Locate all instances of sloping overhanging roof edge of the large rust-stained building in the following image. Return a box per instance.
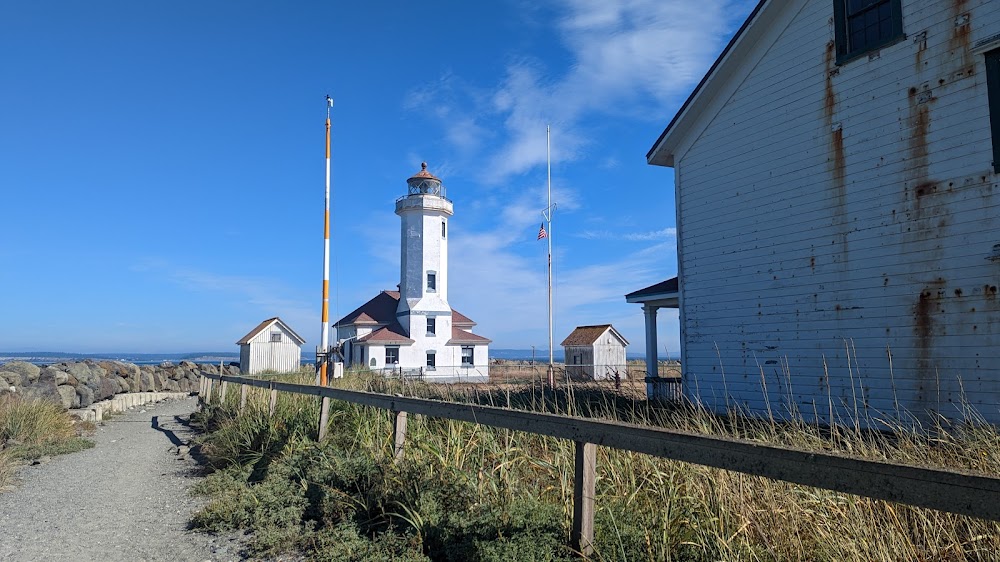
[646,0,772,167]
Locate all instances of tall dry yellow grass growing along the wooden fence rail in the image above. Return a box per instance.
[197,366,1000,562]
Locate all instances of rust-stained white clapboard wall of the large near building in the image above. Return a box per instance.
[675,0,1000,422]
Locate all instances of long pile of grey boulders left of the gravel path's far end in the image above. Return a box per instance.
[0,359,240,409]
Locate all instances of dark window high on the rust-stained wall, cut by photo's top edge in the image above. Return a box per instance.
[833,0,903,64]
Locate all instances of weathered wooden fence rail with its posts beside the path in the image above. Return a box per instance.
[201,373,1000,555]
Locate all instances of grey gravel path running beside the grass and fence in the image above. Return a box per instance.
[0,398,248,562]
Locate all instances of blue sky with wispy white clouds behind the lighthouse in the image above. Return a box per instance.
[0,0,755,356]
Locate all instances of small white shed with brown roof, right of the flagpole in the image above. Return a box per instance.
[560,324,628,380]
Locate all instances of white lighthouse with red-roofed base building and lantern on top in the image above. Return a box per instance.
[335,163,490,382]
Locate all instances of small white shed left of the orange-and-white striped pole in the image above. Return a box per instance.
[236,316,306,375]
